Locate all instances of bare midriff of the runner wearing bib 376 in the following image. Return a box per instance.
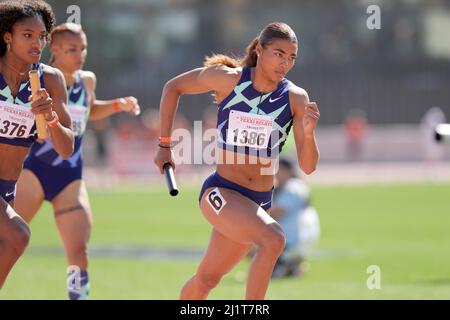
[0,143,29,181]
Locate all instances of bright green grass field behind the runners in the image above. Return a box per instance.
[0,184,450,299]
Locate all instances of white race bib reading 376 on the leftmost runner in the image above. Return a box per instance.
[0,101,35,138]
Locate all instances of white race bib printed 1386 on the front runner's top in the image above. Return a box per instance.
[227,110,273,149]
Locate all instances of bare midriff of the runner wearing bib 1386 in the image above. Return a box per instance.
[217,149,274,192]
